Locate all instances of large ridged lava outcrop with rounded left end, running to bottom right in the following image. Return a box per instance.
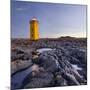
[30,48,84,85]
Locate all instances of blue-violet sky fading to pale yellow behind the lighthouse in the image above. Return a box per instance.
[11,0,87,38]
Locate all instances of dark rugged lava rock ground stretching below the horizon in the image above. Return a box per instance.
[11,37,87,90]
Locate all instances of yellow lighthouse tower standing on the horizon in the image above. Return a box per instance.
[30,18,39,40]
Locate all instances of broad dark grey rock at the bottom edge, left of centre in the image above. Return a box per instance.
[24,72,53,88]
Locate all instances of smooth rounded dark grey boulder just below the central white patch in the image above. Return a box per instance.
[39,52,58,73]
